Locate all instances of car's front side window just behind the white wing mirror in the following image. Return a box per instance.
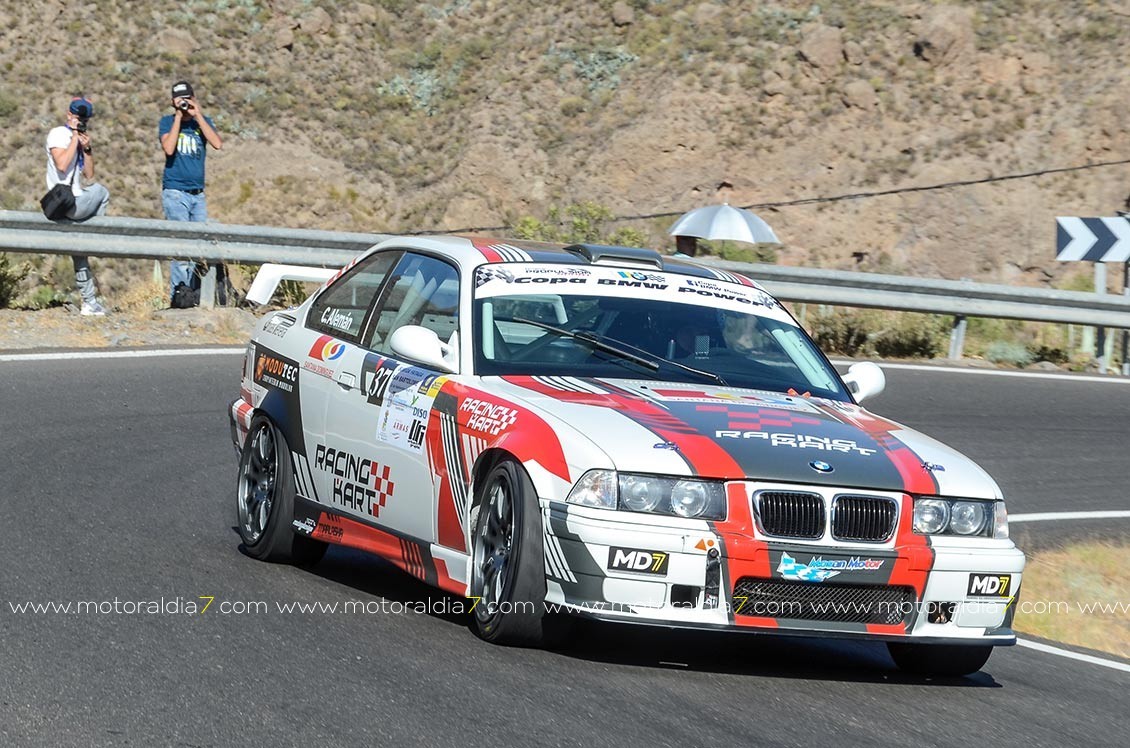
[365,253,459,355]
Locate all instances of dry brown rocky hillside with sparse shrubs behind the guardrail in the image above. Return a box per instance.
[0,0,1130,284]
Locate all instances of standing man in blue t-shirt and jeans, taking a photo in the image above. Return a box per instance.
[157,80,224,298]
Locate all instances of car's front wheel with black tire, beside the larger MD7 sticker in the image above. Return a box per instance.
[470,459,570,646]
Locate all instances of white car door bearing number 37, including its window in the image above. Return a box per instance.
[325,252,459,542]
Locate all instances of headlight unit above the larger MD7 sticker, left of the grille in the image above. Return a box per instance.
[565,470,725,520]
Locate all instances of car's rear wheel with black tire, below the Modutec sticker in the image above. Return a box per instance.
[235,414,327,566]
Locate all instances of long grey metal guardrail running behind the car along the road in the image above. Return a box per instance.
[0,210,1130,358]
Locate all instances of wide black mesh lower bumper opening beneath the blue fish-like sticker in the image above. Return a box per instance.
[733,576,916,625]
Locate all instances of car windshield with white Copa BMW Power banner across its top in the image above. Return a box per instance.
[475,263,850,401]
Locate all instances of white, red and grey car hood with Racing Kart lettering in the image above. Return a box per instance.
[499,376,1000,498]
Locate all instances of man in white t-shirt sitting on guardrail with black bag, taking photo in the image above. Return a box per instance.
[46,95,110,316]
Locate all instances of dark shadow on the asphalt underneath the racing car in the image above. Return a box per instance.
[259,546,1001,688]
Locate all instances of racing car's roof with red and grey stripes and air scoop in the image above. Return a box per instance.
[374,235,764,290]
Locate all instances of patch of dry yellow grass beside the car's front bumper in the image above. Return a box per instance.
[1015,542,1130,658]
